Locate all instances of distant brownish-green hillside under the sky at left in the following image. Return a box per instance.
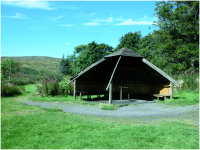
[1,56,61,70]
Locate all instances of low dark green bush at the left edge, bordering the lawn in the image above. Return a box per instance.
[1,82,25,97]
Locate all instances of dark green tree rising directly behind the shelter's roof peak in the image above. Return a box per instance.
[114,31,142,51]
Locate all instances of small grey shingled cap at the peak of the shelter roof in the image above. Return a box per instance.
[105,48,143,58]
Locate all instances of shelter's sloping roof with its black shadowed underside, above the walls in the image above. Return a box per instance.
[68,48,179,86]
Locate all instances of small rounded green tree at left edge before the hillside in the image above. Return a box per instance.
[1,59,20,80]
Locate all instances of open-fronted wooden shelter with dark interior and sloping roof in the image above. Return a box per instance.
[68,48,179,104]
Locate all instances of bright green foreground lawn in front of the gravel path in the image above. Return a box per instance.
[1,85,199,149]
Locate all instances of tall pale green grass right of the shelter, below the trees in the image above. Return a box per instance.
[172,73,199,93]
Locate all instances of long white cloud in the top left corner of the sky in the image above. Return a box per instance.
[1,0,55,10]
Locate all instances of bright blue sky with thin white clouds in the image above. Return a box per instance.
[1,0,157,57]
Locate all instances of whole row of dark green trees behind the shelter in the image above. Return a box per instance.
[59,1,199,75]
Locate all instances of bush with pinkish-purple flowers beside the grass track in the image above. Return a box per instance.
[36,78,59,96]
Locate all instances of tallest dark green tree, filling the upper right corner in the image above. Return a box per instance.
[155,1,199,71]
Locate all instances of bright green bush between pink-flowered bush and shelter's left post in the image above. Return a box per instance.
[59,78,74,96]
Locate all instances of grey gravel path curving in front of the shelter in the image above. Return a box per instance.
[21,100,199,125]
